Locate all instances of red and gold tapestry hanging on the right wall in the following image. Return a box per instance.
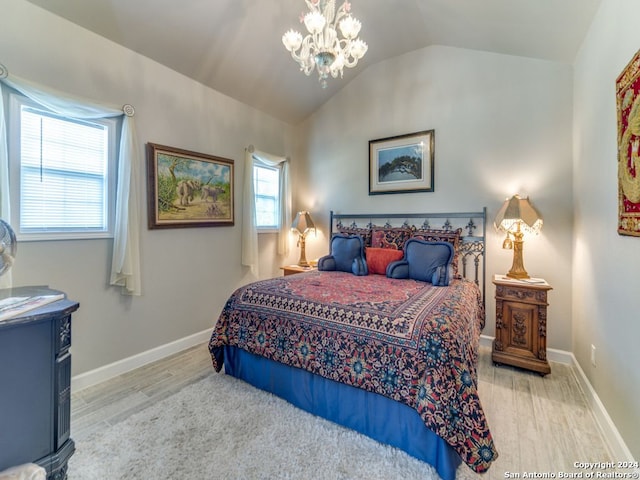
[616,50,640,236]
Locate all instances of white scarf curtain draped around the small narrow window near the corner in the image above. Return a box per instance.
[242,145,291,278]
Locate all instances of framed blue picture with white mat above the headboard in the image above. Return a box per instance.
[369,130,435,195]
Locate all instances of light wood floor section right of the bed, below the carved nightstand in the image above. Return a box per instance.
[458,347,612,479]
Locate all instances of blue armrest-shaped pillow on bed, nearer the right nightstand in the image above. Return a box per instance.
[387,238,453,286]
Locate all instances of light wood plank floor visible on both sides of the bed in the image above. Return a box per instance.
[71,344,613,479]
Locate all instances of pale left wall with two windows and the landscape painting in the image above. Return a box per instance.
[0,0,291,375]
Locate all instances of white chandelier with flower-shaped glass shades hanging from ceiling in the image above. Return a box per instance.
[282,0,368,88]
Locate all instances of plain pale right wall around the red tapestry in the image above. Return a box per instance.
[573,0,640,459]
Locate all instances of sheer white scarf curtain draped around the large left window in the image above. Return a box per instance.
[0,68,142,295]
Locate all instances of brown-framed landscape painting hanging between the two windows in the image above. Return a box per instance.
[147,143,234,229]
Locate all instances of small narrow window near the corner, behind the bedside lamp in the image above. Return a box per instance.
[253,161,280,232]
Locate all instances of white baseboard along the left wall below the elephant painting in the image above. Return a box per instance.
[71,329,211,392]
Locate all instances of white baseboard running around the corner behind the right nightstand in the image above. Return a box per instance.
[480,335,635,462]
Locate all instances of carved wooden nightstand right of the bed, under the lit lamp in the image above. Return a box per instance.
[491,275,551,375]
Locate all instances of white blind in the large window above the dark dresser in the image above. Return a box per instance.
[20,106,109,233]
